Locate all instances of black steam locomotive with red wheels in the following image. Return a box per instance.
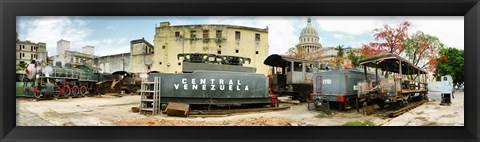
[22,60,104,98]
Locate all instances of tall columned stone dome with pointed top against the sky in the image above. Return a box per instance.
[296,18,322,54]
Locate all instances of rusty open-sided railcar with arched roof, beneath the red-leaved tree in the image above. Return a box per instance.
[357,53,428,107]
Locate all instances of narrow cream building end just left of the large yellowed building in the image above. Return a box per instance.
[130,38,155,73]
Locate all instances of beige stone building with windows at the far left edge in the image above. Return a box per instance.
[15,34,48,67]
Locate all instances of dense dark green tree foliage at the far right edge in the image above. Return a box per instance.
[435,48,465,85]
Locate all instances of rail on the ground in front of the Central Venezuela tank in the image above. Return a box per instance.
[188,106,290,115]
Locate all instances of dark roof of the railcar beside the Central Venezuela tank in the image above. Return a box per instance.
[263,54,316,67]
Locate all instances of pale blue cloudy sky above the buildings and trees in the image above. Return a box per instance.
[16,16,464,56]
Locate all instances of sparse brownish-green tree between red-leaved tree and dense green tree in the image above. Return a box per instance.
[403,31,445,71]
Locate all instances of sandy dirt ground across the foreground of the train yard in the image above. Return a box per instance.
[17,92,464,126]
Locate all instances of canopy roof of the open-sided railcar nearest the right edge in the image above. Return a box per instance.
[360,53,427,75]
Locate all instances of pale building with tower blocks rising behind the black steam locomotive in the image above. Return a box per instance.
[53,39,95,66]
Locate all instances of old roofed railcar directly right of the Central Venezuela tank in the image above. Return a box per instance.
[263,54,326,101]
